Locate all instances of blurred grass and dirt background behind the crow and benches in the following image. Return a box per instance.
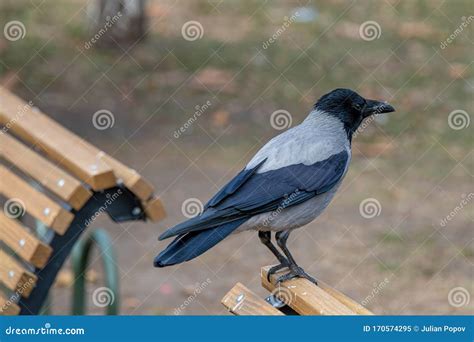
[0,0,474,315]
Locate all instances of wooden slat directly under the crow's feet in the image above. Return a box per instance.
[261,266,355,315]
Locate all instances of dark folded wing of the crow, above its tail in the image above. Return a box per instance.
[160,151,349,240]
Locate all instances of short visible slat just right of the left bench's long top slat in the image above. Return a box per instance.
[100,153,153,201]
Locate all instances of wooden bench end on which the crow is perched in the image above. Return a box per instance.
[221,266,373,316]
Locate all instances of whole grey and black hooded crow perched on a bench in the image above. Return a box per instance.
[154,89,395,283]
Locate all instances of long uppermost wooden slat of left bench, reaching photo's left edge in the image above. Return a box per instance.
[0,87,116,190]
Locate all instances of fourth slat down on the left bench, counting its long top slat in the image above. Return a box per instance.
[0,212,52,268]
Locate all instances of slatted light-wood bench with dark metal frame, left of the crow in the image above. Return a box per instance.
[0,87,165,315]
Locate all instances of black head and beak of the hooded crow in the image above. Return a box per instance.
[314,88,395,136]
